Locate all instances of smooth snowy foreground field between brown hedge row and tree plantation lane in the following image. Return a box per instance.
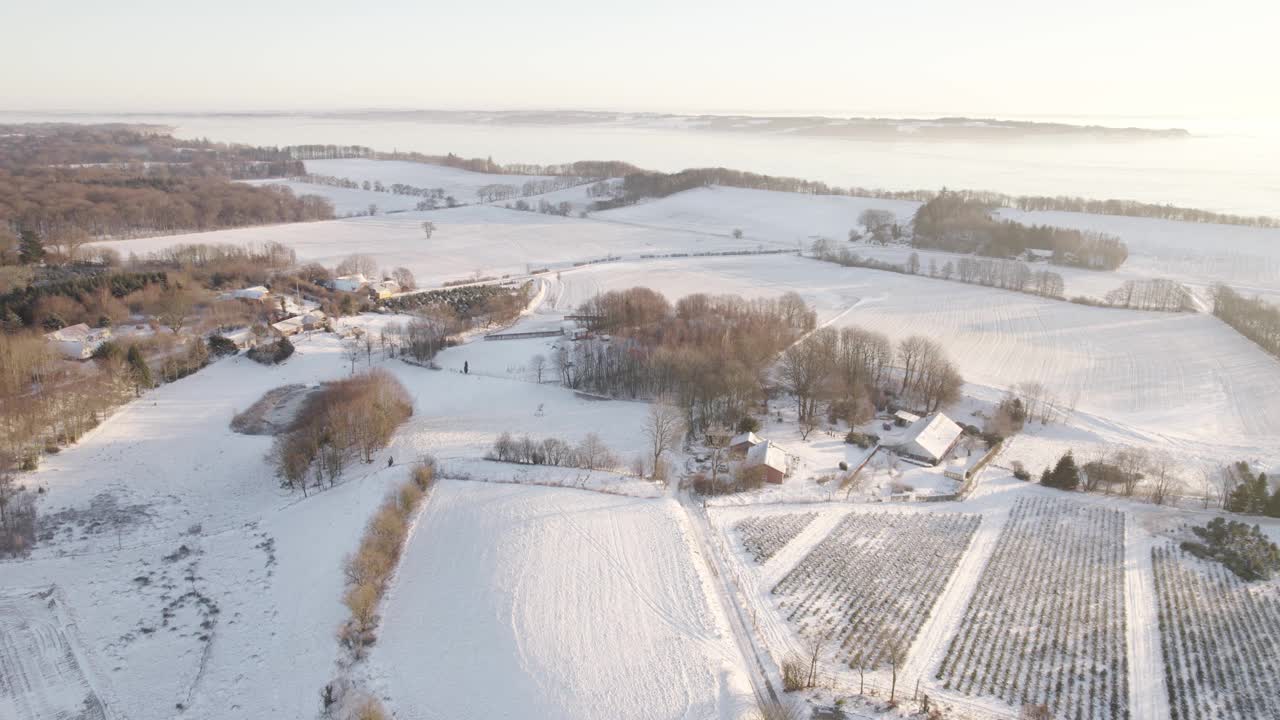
[370,480,751,719]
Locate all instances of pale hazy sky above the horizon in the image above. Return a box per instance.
[0,0,1280,119]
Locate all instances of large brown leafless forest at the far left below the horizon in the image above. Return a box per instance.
[0,124,333,250]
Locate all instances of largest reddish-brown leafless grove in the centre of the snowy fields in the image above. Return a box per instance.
[553,288,815,433]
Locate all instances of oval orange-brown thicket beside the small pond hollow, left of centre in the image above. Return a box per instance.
[268,369,413,495]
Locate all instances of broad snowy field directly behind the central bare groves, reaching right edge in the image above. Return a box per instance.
[550,256,1280,471]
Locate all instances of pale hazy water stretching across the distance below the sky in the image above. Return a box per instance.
[0,113,1280,215]
